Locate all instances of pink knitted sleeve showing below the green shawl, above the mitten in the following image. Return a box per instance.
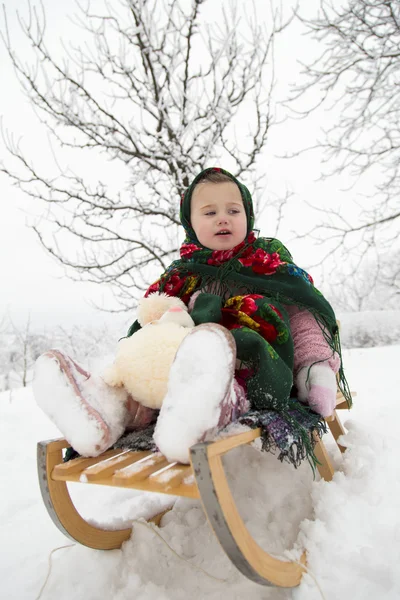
[285,306,340,374]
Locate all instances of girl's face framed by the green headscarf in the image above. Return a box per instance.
[190,181,247,250]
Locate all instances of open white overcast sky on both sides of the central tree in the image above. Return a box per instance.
[0,0,378,325]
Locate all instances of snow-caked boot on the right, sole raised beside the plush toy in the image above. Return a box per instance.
[154,323,244,463]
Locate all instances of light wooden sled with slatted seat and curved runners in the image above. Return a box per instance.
[38,386,347,587]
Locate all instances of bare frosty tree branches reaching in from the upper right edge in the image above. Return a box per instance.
[292,0,400,274]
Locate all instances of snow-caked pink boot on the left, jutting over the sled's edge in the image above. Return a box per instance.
[32,350,129,456]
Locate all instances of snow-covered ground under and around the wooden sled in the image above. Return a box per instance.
[0,346,400,600]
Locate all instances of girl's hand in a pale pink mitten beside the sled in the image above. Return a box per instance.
[296,363,337,417]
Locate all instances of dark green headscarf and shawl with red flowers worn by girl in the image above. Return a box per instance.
[128,168,351,468]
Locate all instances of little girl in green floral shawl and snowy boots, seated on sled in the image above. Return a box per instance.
[34,168,351,465]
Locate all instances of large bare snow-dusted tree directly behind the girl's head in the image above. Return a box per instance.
[1,0,290,310]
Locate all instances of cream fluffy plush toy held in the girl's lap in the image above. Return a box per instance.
[103,293,194,408]
